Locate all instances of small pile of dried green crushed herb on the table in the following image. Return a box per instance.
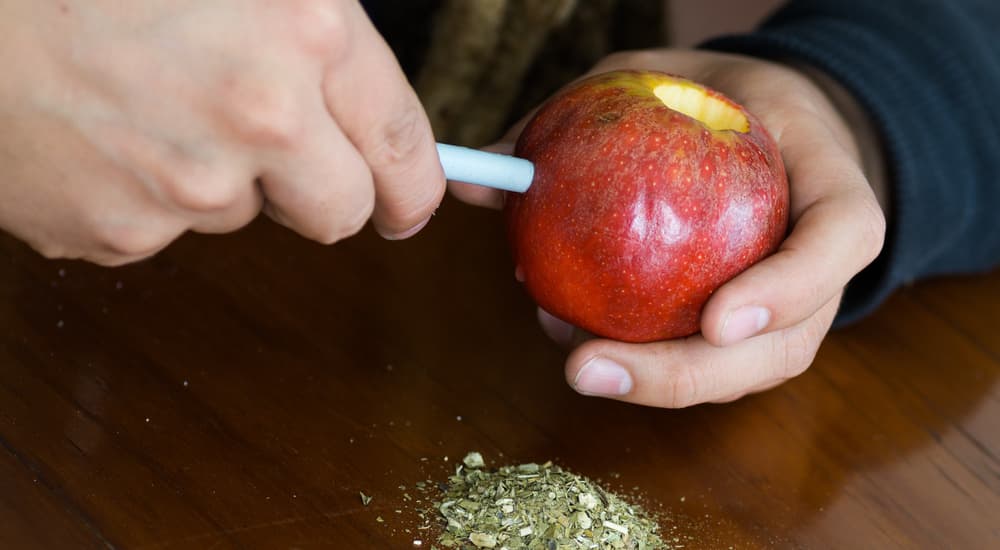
[437,453,667,550]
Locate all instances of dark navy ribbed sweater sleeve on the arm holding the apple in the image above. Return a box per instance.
[702,0,1000,325]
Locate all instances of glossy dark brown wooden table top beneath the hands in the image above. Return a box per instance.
[0,200,1000,549]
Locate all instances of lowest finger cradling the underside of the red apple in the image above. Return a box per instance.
[566,299,838,408]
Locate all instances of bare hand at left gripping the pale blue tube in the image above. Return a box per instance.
[0,0,445,265]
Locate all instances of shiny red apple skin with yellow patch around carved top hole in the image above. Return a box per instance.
[504,71,789,342]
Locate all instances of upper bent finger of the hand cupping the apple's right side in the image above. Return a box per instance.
[701,119,885,346]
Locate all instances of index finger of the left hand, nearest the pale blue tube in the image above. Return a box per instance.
[323,2,445,238]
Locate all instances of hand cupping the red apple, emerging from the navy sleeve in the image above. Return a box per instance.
[452,50,885,407]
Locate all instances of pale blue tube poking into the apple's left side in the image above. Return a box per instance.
[437,143,535,193]
